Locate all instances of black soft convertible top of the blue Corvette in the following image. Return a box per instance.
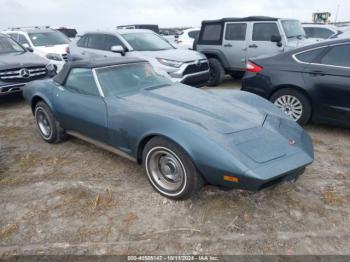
[53,57,147,85]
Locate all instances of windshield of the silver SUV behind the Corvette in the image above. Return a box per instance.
[123,33,174,51]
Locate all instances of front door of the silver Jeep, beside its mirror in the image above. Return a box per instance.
[247,22,283,59]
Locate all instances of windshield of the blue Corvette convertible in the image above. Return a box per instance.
[96,63,171,97]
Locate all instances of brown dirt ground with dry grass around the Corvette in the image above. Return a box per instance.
[0,81,350,255]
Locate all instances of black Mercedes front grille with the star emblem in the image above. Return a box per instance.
[0,66,47,82]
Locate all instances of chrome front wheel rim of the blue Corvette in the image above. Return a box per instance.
[146,147,186,194]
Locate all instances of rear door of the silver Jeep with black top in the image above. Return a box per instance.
[222,22,248,69]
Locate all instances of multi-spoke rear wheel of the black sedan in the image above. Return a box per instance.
[270,88,311,125]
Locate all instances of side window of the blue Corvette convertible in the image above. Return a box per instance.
[64,68,100,96]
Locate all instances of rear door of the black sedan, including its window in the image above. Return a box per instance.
[304,43,350,123]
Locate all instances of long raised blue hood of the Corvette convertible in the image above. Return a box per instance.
[126,84,266,134]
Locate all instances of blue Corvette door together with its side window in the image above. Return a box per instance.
[54,68,109,143]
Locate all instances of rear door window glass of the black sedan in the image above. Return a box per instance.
[321,44,350,67]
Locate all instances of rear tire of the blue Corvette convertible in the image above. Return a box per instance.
[34,101,67,144]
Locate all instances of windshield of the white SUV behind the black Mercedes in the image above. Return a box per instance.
[28,32,69,46]
